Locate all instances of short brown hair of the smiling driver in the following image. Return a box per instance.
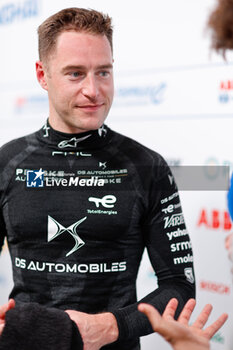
[38,7,113,60]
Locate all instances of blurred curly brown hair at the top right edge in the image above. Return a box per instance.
[208,0,233,57]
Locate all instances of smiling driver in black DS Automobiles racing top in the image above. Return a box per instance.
[0,9,195,350]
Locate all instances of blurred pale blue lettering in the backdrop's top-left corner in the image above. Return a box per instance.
[0,0,39,25]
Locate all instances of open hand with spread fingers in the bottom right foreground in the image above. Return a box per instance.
[138,299,228,350]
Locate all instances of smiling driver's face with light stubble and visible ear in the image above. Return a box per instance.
[36,31,114,133]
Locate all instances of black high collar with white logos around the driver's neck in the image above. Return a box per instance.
[37,120,112,151]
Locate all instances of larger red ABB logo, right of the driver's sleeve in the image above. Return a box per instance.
[197,209,232,231]
